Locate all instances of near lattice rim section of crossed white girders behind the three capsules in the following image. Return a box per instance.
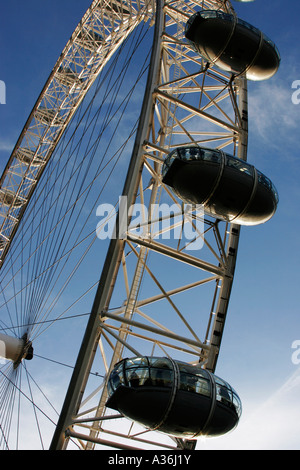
[47,1,247,448]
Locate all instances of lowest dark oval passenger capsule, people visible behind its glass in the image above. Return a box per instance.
[106,357,241,439]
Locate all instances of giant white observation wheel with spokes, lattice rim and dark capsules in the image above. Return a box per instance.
[0,0,280,449]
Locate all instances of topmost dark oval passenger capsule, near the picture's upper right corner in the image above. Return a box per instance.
[185,10,280,80]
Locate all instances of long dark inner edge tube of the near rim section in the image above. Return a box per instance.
[51,0,163,449]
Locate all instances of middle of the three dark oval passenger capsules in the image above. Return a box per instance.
[162,147,278,225]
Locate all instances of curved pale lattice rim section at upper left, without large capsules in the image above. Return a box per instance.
[0,0,153,267]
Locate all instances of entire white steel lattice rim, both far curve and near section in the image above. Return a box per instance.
[0,0,247,449]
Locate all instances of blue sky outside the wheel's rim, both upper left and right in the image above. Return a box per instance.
[0,0,300,449]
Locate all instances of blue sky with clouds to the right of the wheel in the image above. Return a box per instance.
[206,0,300,449]
